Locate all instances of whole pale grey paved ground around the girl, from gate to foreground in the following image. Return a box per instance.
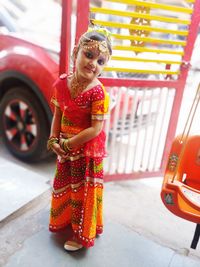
[0,151,200,267]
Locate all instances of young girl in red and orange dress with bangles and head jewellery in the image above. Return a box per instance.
[47,29,112,251]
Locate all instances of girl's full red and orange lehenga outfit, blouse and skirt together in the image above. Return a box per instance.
[49,76,109,247]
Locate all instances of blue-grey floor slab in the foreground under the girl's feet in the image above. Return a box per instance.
[2,210,200,267]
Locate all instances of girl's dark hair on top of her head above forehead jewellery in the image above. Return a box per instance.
[79,30,112,55]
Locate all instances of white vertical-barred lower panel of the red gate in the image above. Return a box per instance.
[105,87,175,174]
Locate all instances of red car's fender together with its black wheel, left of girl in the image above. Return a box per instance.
[0,34,58,161]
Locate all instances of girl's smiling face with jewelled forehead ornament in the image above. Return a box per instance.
[75,42,109,81]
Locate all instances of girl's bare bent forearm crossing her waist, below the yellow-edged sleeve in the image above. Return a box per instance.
[69,120,103,148]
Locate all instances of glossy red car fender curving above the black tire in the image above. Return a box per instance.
[0,35,58,111]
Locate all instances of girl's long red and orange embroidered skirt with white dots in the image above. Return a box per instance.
[49,151,103,247]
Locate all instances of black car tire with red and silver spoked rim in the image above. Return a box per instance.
[0,87,50,162]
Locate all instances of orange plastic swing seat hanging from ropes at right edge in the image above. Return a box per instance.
[161,85,200,249]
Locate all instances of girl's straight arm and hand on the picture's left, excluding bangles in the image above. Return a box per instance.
[50,106,66,157]
